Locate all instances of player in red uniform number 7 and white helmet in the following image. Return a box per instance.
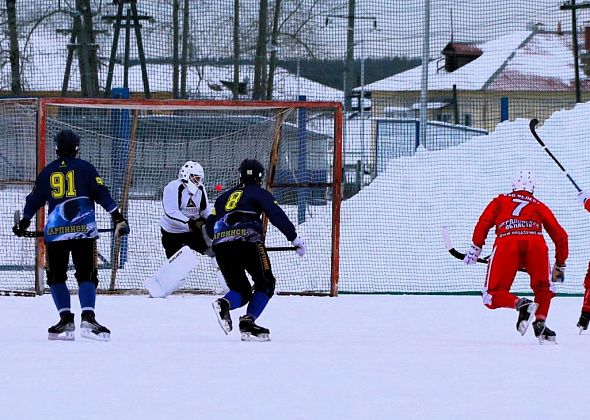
[463,170,568,343]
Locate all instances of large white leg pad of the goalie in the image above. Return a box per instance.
[144,245,197,298]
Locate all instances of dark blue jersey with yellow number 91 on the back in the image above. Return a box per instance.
[23,157,117,242]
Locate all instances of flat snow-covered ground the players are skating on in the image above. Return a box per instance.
[0,295,590,420]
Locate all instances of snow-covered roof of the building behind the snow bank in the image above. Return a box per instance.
[364,31,585,92]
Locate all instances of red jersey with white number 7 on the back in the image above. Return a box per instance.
[473,191,569,264]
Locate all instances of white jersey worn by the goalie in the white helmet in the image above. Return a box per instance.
[160,179,211,233]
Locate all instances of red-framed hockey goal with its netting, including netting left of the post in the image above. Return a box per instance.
[0,98,342,296]
